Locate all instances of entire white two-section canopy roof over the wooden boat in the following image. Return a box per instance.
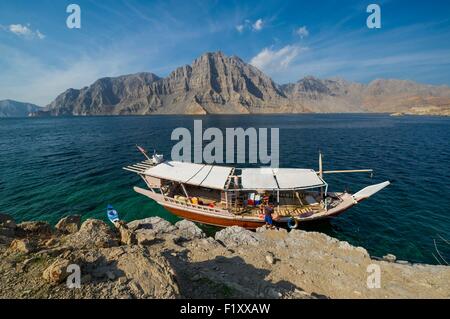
[144,161,326,190]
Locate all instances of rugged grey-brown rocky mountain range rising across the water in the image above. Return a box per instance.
[32,52,450,116]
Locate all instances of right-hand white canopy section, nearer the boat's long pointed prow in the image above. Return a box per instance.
[241,168,326,190]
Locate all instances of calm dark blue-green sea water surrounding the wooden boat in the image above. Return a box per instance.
[0,115,450,264]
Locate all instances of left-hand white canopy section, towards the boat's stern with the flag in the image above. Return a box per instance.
[145,161,232,189]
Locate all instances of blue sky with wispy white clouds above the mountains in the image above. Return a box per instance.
[0,0,450,105]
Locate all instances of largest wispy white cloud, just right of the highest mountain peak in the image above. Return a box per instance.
[250,45,306,72]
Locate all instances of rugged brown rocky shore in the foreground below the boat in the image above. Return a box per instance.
[0,214,450,298]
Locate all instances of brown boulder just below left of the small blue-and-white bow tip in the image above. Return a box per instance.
[65,219,119,249]
